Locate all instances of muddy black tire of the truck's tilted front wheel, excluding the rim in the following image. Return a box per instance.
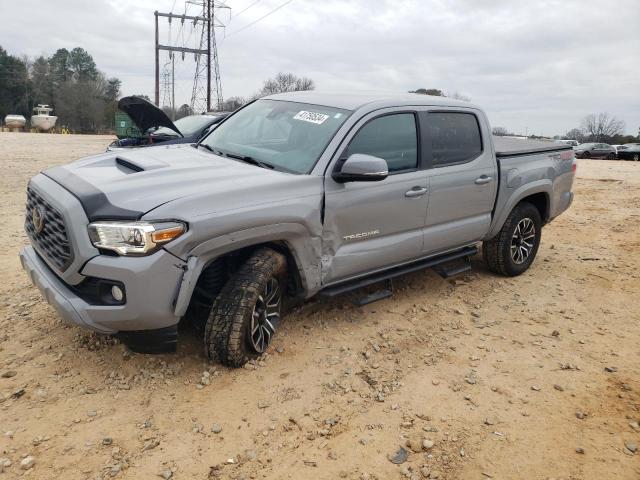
[204,248,287,367]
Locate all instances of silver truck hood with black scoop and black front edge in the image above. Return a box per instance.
[43,145,317,221]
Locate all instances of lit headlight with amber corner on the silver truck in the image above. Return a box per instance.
[89,222,186,255]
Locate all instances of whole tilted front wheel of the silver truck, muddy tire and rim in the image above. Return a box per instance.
[204,248,286,367]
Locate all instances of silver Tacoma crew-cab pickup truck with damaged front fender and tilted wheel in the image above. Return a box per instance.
[20,92,575,366]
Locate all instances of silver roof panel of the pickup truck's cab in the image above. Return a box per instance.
[264,90,478,110]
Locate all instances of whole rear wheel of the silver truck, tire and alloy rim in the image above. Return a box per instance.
[482,202,542,277]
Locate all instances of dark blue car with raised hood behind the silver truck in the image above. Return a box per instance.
[107,96,229,151]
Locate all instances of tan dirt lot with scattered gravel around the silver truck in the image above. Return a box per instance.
[0,133,640,480]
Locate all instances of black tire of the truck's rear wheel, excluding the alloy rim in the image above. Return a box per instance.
[482,202,542,277]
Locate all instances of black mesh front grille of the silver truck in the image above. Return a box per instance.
[24,188,73,272]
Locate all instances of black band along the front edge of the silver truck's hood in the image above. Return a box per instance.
[42,167,144,222]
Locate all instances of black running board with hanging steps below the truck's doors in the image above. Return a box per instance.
[319,246,478,303]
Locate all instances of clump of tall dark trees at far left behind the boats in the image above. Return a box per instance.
[0,47,122,133]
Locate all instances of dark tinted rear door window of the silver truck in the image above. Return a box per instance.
[427,112,482,167]
